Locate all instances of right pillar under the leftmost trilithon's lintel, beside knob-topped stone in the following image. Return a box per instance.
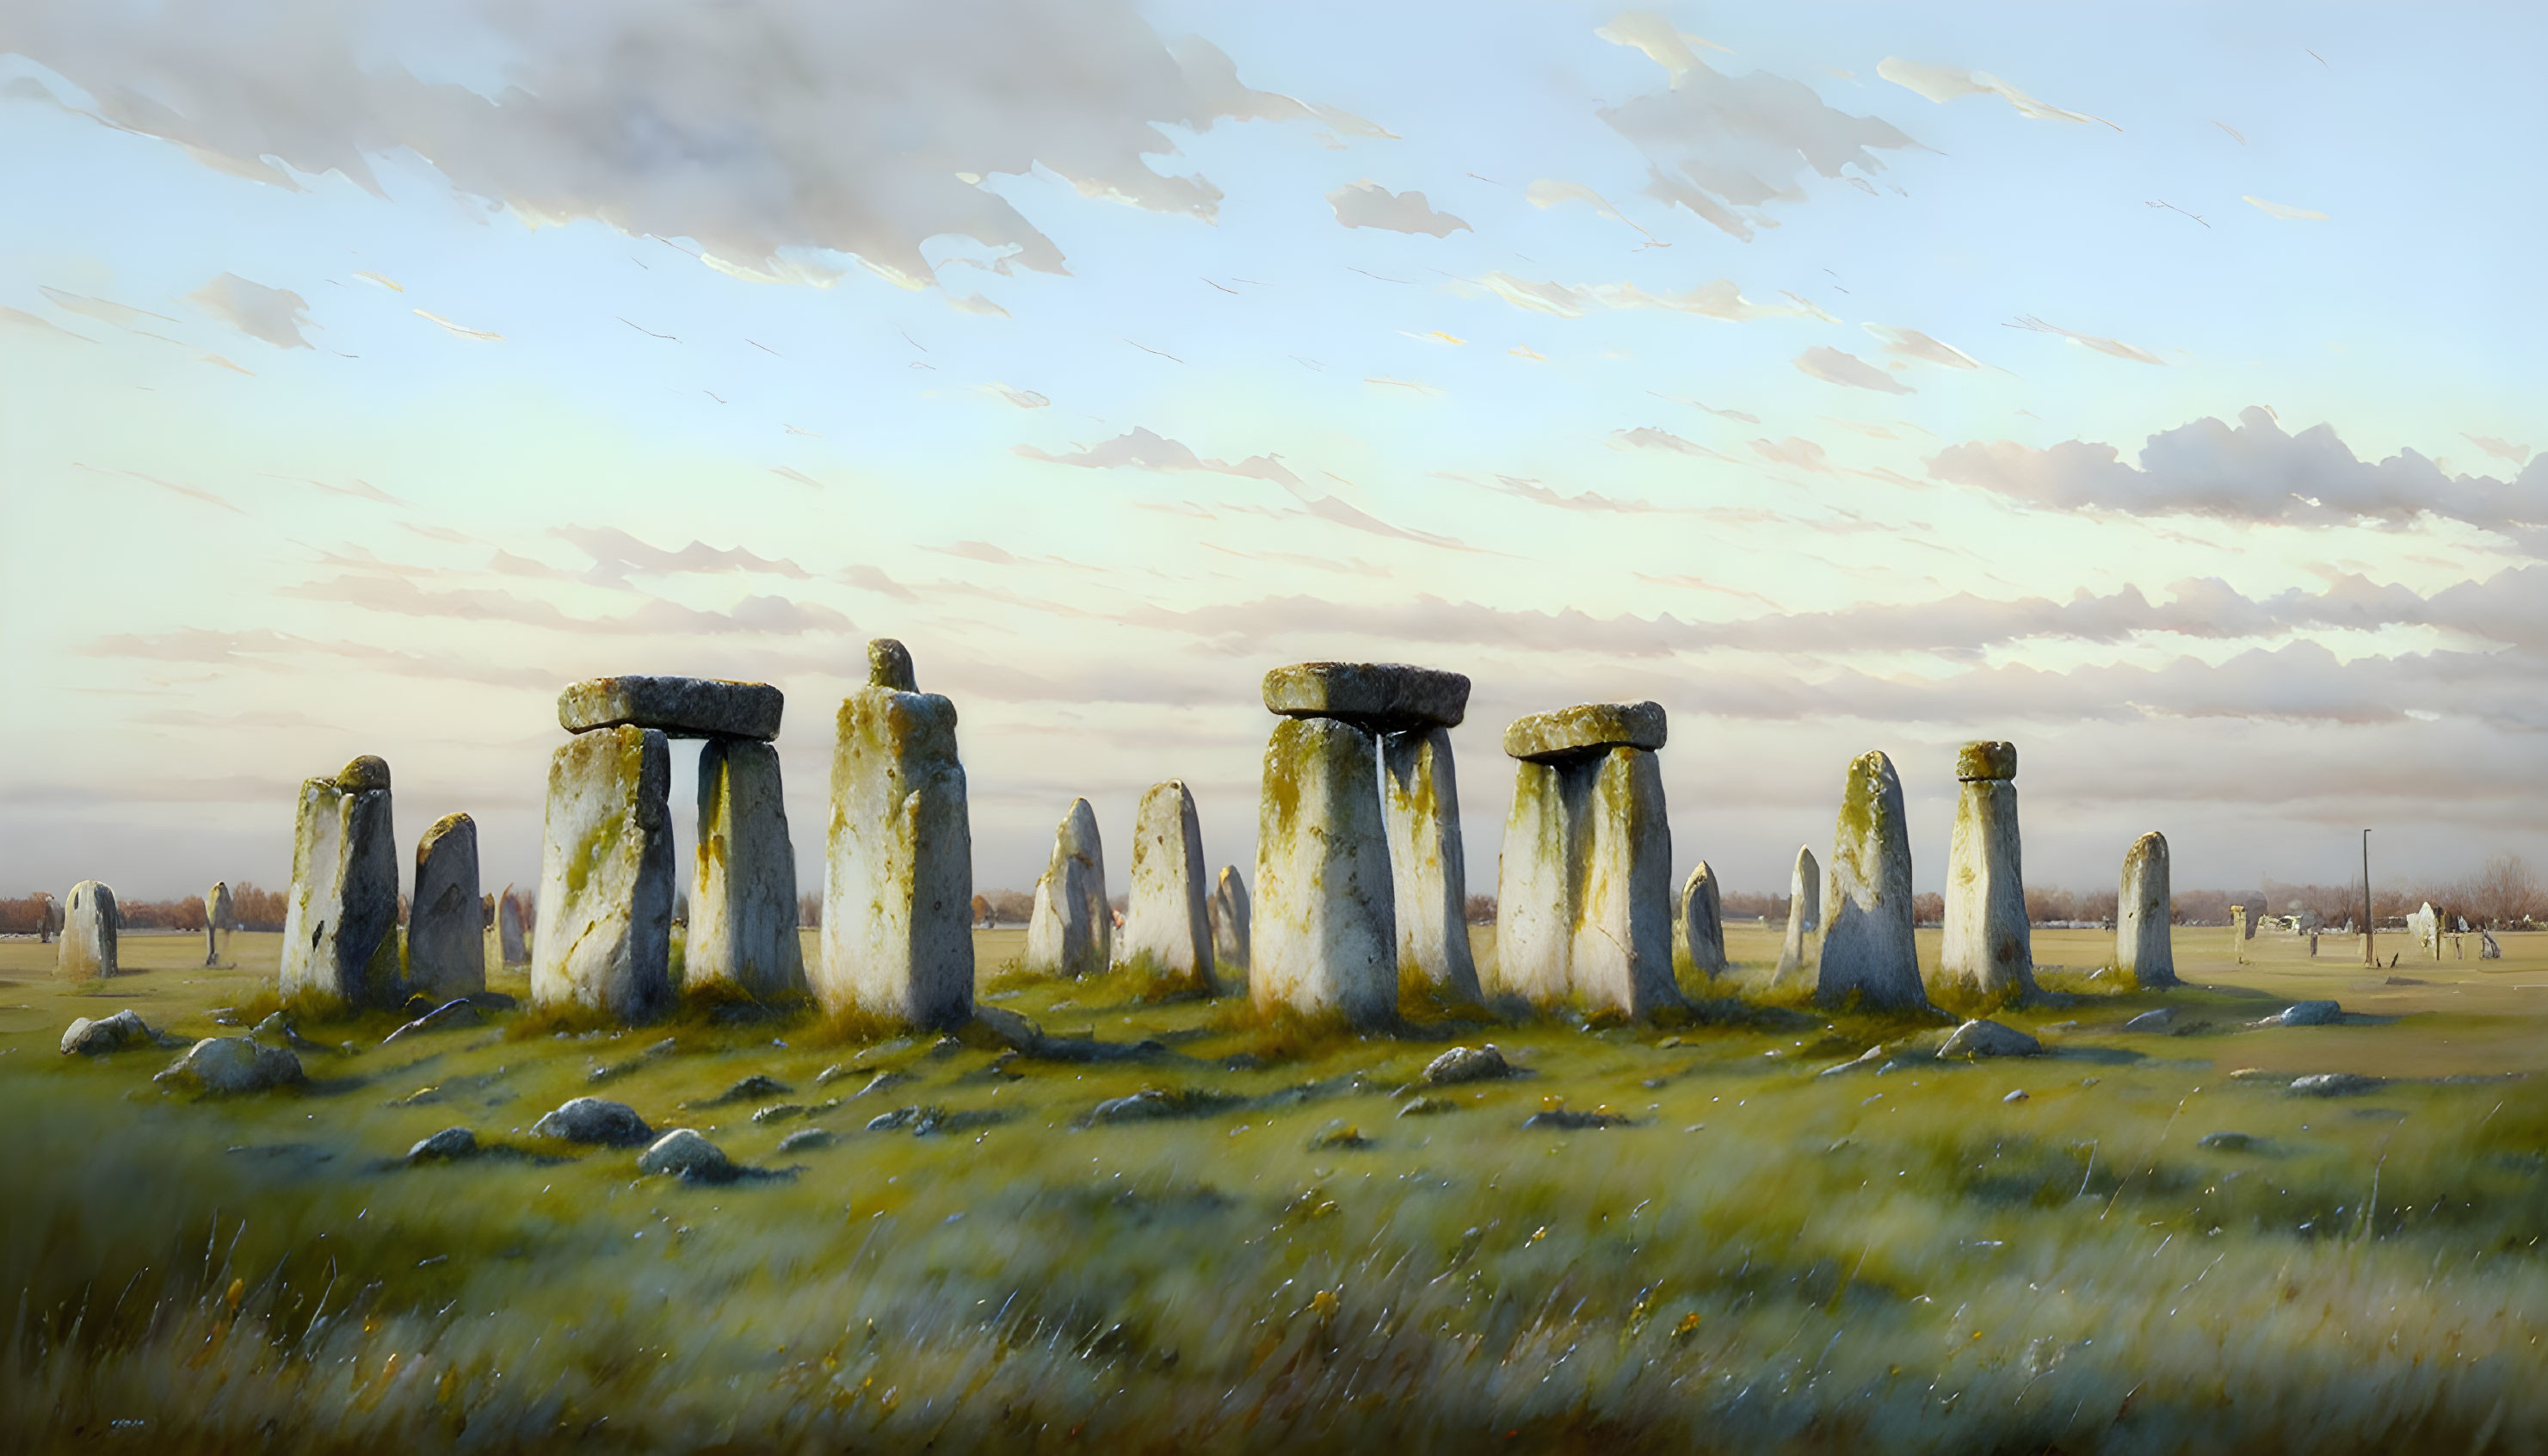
[681,737,808,1003]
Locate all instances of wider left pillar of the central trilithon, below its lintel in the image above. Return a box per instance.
[1249,719,1399,1025]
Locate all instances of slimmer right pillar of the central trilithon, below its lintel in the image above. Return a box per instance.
[1381,724,1483,1003]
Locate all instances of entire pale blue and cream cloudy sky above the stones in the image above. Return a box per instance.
[0,0,2548,898]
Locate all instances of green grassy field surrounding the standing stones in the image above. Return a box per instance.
[0,926,2548,1453]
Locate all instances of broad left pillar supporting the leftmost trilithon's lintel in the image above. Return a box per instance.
[530,727,673,1022]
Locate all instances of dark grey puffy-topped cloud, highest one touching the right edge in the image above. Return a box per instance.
[1928,405,2548,530]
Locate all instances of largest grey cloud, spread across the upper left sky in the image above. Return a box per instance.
[10,0,1389,286]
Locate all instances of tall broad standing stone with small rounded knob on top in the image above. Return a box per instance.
[813,638,973,1025]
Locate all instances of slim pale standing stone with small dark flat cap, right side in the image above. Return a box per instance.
[1931,742,2036,1003]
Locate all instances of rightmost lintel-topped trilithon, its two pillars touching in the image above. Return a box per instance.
[1488,704,1681,1017]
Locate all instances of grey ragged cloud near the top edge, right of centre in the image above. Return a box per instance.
[1598,10,1919,243]
